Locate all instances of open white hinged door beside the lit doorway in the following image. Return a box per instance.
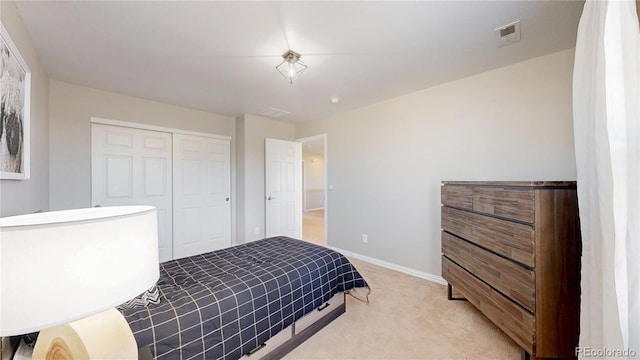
[265,139,302,239]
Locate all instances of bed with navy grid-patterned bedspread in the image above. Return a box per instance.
[121,236,368,359]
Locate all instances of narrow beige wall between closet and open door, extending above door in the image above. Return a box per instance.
[236,114,295,243]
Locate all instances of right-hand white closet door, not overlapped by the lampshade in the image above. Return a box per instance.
[173,134,231,258]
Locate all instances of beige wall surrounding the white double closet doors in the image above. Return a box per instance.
[49,80,235,209]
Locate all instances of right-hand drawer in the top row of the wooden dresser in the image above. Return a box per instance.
[473,187,535,223]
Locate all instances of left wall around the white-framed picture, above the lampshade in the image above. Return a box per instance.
[0,0,49,216]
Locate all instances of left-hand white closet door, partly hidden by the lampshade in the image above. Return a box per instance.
[91,124,173,261]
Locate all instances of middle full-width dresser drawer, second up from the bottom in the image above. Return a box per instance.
[442,232,535,313]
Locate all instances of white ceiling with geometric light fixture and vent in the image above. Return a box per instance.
[17,1,583,122]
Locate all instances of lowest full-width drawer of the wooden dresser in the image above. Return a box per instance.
[442,256,535,354]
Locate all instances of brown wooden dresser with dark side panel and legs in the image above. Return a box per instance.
[441,181,582,359]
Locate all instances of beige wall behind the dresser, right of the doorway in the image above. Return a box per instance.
[296,50,576,275]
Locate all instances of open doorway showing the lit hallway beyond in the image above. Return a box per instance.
[297,134,328,246]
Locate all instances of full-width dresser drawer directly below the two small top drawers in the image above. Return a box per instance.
[442,207,535,267]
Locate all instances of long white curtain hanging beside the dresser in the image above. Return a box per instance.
[573,0,640,358]
